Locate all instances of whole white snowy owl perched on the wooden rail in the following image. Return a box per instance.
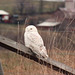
[24,25,48,59]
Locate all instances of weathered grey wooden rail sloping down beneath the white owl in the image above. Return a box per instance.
[0,35,75,75]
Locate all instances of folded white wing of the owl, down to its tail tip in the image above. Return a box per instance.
[27,32,48,58]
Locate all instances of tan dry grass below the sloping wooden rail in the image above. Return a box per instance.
[0,51,64,75]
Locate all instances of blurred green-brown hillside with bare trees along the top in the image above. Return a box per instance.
[0,0,64,14]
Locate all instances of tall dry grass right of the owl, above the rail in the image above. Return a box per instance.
[40,30,75,69]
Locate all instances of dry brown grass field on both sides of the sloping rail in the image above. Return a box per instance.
[0,24,75,75]
